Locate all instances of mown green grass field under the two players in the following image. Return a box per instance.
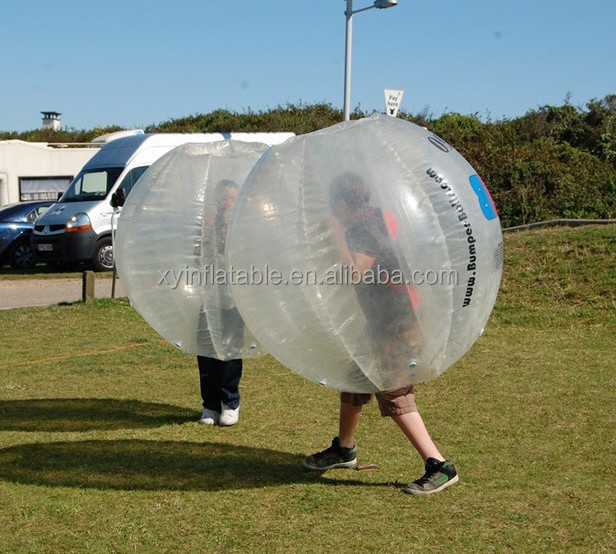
[0,226,616,552]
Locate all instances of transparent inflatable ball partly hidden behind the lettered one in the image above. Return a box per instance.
[115,140,268,360]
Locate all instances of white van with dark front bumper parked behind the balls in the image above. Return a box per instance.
[31,129,294,271]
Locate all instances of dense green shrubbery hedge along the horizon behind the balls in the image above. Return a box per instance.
[0,95,616,227]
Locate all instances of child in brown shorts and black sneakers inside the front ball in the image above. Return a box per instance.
[304,173,459,494]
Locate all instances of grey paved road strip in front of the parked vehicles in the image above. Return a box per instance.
[0,277,126,310]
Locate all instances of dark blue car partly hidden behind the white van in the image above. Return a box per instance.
[0,200,54,269]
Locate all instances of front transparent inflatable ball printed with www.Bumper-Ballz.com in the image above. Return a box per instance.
[227,115,503,392]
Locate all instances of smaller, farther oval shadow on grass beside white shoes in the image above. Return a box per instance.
[0,398,197,432]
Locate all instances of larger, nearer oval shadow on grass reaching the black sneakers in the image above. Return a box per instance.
[0,439,390,491]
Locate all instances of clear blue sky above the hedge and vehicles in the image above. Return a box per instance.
[0,0,616,132]
